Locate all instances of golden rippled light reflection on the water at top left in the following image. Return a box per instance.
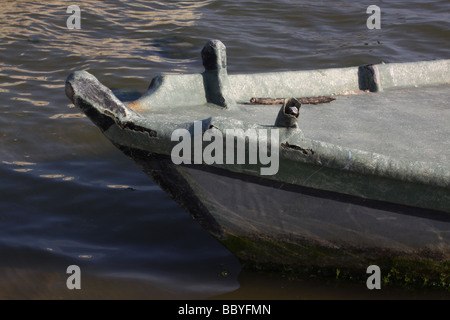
[0,0,211,63]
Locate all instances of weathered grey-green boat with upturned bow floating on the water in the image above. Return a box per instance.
[66,40,450,287]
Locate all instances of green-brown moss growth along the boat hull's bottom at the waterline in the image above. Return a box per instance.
[223,235,450,291]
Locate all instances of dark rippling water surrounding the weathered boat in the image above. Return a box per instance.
[0,0,450,299]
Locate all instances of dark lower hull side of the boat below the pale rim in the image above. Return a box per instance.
[118,146,450,286]
